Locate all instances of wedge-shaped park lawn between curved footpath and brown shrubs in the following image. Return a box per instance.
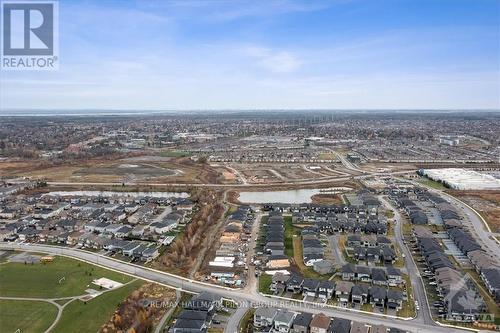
[53,281,144,333]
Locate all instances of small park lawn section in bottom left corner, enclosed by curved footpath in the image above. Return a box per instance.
[0,300,57,333]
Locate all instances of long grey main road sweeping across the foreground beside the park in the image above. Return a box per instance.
[0,242,470,333]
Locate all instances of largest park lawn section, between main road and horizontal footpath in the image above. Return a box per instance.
[0,253,131,298]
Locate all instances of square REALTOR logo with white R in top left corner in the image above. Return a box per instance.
[1,1,58,70]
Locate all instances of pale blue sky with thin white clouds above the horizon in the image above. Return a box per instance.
[0,0,500,112]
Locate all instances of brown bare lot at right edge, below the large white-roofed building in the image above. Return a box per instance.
[447,190,500,232]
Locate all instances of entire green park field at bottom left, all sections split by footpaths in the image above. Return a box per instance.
[0,257,144,333]
